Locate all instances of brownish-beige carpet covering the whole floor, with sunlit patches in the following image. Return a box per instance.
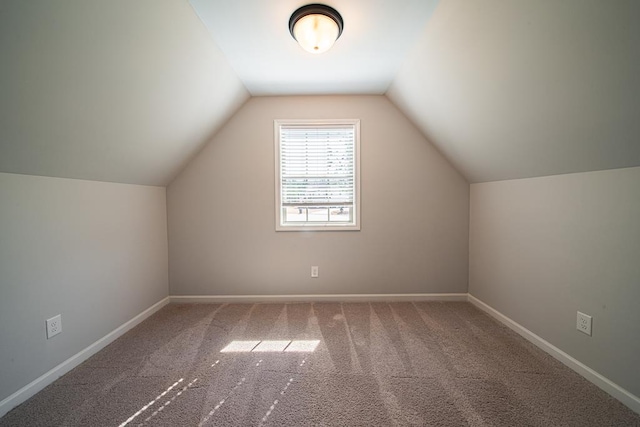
[0,302,640,426]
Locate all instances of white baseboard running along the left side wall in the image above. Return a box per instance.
[0,297,170,417]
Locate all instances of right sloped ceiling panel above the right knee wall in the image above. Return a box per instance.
[387,0,640,182]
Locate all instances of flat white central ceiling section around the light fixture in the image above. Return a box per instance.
[190,0,438,96]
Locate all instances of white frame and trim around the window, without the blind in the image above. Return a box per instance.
[273,119,360,231]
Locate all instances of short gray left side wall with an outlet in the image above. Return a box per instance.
[0,173,168,401]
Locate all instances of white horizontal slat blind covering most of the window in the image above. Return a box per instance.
[280,125,355,206]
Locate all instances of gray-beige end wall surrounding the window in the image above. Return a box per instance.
[167,96,469,295]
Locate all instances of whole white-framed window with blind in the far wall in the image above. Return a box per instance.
[274,120,360,231]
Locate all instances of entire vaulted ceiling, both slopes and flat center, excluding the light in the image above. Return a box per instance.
[0,0,640,185]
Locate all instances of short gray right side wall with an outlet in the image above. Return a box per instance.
[469,168,640,396]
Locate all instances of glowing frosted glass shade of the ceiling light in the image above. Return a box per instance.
[293,14,340,53]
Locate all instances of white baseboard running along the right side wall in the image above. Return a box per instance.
[469,294,640,414]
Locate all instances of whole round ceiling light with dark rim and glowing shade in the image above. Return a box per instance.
[289,4,344,53]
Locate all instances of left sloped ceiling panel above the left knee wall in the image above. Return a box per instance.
[0,0,249,185]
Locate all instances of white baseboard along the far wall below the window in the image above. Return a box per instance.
[169,293,467,303]
